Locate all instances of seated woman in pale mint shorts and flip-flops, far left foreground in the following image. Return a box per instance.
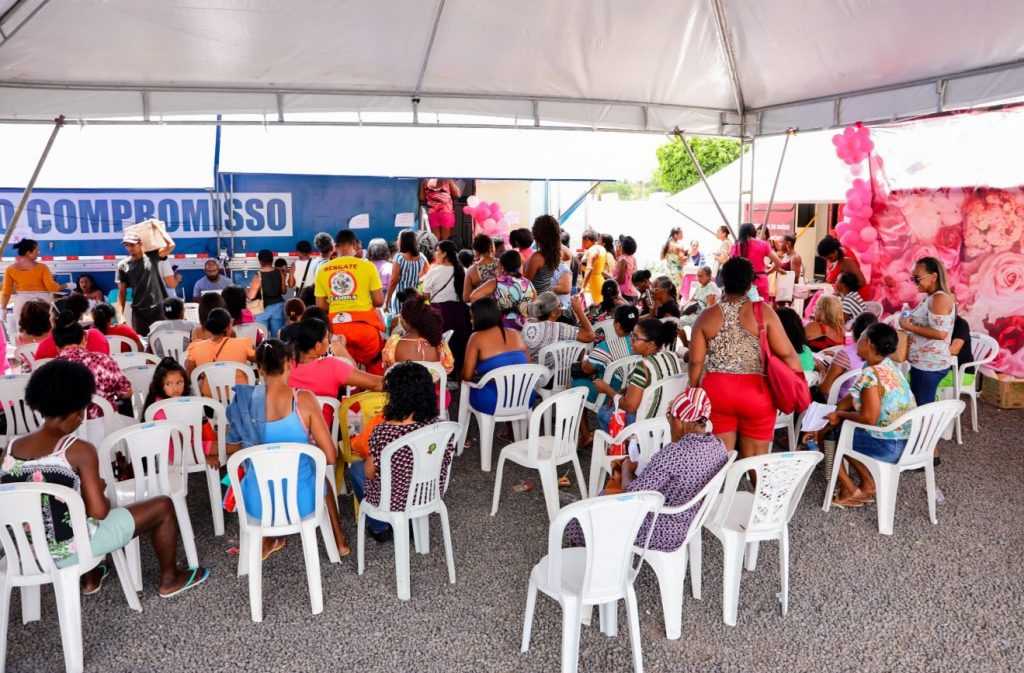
[0,360,210,598]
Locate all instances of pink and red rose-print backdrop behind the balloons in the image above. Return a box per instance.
[870,186,1024,378]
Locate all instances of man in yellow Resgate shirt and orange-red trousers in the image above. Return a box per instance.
[315,229,384,374]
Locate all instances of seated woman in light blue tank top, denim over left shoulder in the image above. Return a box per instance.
[227,339,351,558]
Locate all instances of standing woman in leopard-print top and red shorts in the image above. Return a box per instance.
[689,257,803,458]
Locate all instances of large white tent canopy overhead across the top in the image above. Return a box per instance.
[0,0,1024,135]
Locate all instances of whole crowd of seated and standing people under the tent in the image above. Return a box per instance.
[0,215,971,610]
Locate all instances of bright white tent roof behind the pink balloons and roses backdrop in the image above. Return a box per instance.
[667,103,1024,220]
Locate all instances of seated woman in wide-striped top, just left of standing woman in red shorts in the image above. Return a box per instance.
[597,318,683,430]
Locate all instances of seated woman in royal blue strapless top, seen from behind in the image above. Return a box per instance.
[462,297,529,414]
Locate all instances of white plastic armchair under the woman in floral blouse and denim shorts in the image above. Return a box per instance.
[822,399,967,535]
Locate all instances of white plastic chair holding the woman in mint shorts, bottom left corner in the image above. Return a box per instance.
[0,482,142,673]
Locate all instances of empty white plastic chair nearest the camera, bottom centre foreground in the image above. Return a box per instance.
[520,491,665,673]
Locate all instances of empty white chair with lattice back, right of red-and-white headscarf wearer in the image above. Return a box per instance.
[705,451,823,626]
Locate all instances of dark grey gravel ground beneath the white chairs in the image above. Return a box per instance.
[7,406,1024,673]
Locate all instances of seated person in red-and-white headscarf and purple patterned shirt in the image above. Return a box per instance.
[566,388,728,551]
